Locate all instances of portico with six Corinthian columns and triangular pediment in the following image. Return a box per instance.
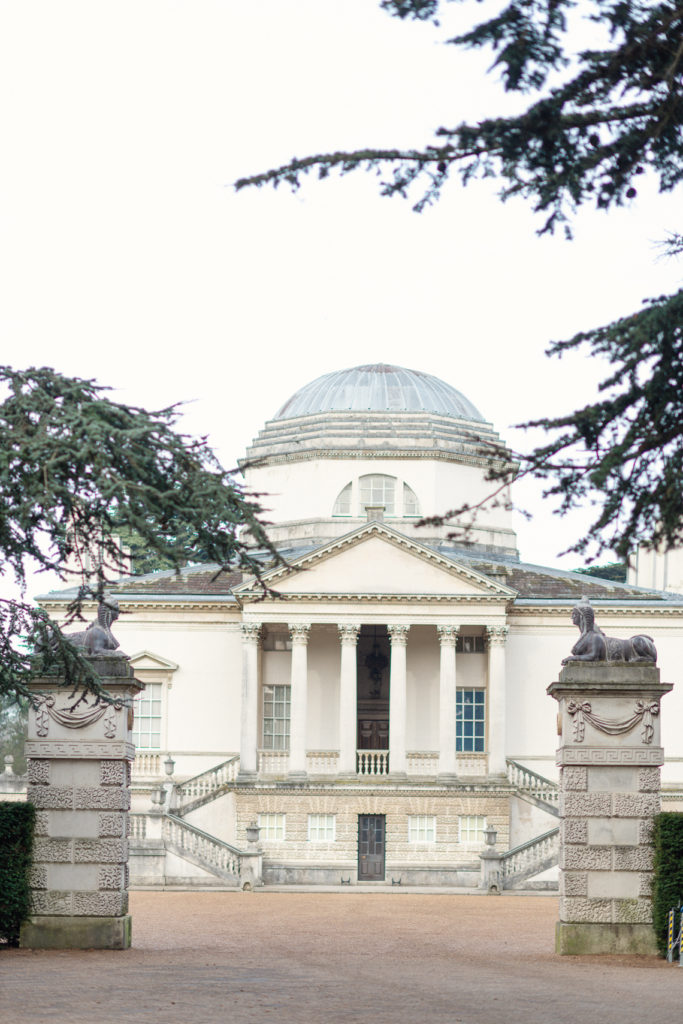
[240,522,510,785]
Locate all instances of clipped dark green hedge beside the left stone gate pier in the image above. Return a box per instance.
[0,803,36,946]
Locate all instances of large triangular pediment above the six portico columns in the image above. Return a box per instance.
[236,522,515,600]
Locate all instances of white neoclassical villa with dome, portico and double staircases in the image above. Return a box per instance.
[42,365,683,885]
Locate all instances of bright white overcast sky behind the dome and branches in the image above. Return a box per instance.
[0,0,681,589]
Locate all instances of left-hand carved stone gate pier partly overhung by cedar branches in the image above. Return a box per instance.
[20,655,142,949]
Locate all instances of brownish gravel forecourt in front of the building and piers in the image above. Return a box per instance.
[0,892,683,1024]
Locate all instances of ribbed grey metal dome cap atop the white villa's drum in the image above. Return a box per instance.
[274,362,484,423]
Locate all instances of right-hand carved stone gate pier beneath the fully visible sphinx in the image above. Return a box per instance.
[548,662,672,953]
